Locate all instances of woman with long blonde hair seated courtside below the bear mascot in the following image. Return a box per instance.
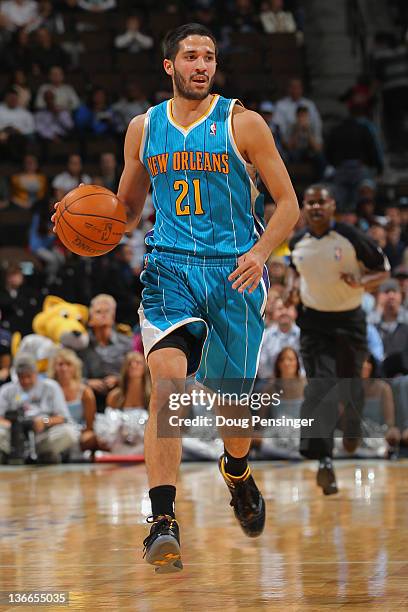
[48,349,108,451]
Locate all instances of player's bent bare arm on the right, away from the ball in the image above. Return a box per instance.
[228,106,299,293]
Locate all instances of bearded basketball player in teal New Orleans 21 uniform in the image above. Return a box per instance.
[86,24,299,572]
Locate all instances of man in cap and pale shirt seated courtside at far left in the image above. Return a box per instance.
[0,353,78,463]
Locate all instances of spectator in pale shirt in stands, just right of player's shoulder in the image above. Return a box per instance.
[275,79,322,142]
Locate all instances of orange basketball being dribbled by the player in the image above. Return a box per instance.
[55,185,126,257]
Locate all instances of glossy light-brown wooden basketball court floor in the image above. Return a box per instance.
[0,461,408,612]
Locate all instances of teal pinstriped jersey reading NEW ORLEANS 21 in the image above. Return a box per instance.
[140,95,263,257]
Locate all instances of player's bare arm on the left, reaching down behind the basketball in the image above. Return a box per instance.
[118,115,150,232]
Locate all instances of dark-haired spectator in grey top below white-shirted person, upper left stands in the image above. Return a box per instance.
[34,89,74,142]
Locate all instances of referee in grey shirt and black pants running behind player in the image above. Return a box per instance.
[289,184,389,495]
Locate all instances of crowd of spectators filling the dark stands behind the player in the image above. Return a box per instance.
[0,0,408,460]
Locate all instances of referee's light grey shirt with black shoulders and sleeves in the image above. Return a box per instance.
[289,222,390,312]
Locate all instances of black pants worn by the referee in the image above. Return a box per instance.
[298,308,367,459]
